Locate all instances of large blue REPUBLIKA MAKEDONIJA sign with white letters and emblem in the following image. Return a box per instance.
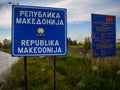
[12,5,67,56]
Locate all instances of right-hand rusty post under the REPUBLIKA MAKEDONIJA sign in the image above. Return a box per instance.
[53,56,56,90]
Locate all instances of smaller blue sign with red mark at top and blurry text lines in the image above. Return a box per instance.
[91,14,116,58]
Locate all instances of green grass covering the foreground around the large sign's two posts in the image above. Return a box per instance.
[2,53,120,90]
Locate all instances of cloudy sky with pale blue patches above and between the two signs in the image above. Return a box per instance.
[0,0,120,42]
